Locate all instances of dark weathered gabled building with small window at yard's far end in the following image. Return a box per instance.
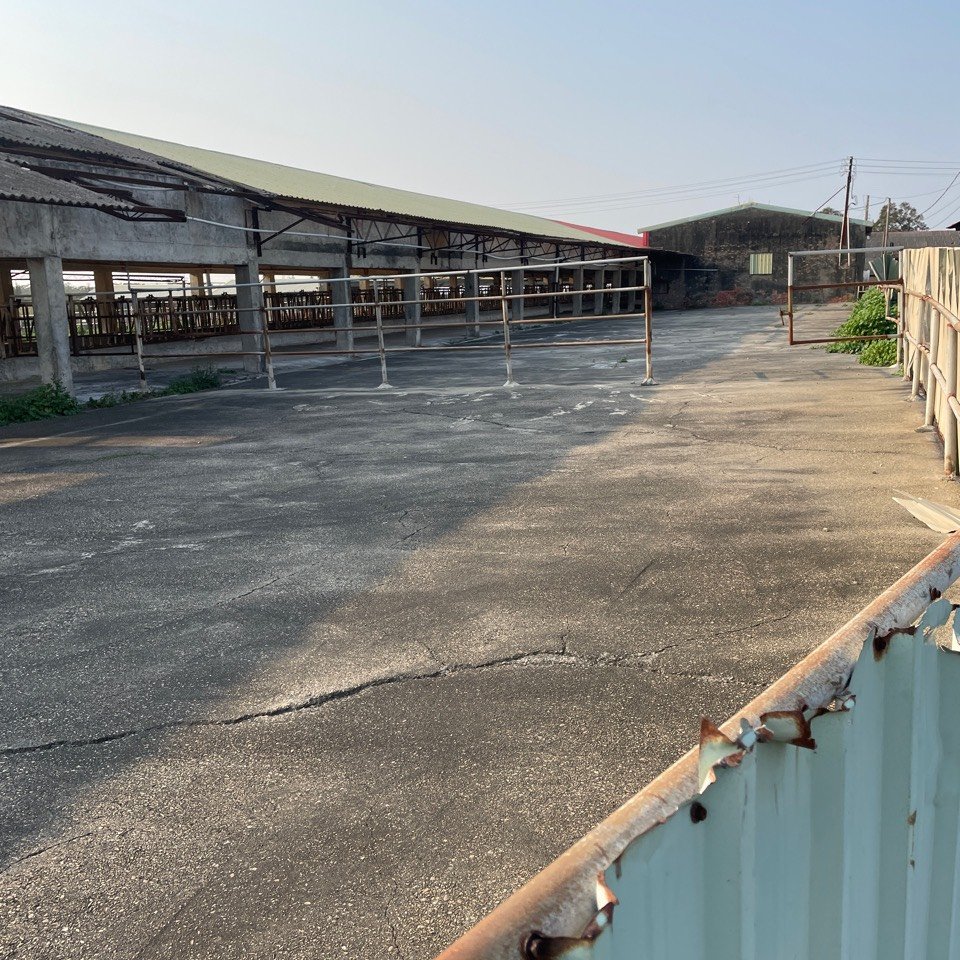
[638,202,870,301]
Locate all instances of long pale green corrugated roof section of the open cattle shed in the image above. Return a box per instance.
[56,118,620,244]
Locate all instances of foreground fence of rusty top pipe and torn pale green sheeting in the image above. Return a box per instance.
[441,534,960,960]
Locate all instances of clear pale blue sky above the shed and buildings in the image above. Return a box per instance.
[0,0,960,231]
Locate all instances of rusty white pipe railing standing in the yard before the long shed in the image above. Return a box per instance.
[65,256,653,390]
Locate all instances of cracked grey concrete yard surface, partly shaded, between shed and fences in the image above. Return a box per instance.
[0,308,960,960]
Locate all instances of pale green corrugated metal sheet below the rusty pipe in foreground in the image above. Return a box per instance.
[588,635,960,960]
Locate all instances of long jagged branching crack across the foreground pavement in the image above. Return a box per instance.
[0,613,792,757]
